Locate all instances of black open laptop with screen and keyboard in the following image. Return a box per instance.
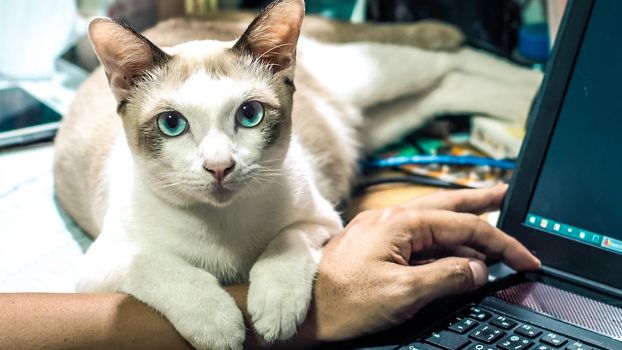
[346,0,622,350]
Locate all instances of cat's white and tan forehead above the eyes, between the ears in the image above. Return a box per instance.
[134,40,287,122]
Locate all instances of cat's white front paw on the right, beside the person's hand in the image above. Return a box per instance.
[248,261,316,342]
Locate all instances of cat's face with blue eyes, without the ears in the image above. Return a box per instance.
[128,42,294,205]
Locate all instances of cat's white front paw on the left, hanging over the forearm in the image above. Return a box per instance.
[173,297,246,350]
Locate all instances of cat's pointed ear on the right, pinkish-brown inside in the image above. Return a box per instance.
[233,0,305,73]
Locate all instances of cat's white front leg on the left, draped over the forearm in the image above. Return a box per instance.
[77,242,246,349]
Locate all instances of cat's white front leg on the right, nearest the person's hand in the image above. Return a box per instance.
[248,224,330,342]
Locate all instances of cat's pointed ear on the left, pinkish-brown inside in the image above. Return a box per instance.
[89,18,170,104]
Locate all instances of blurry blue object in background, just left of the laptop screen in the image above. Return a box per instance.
[518,23,550,62]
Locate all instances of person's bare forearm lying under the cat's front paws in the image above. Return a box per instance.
[0,285,326,349]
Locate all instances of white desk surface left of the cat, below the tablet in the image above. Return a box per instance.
[0,143,91,292]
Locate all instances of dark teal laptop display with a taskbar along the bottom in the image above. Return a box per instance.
[524,1,622,254]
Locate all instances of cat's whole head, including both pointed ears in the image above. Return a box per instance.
[90,0,303,206]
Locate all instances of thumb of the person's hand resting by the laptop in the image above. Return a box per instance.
[411,257,488,304]
